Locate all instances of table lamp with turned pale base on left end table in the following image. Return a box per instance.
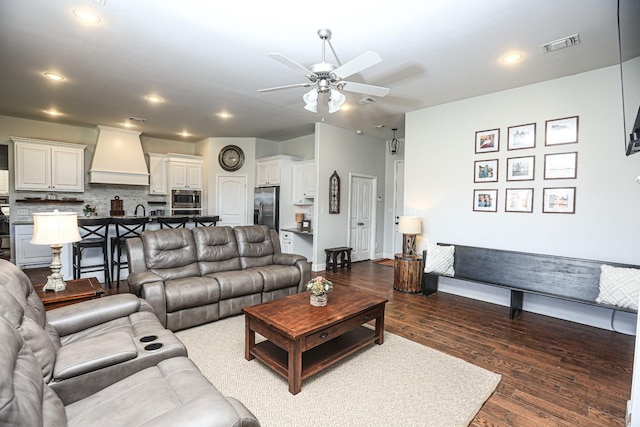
[31,209,82,291]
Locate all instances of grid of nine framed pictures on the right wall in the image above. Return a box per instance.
[473,116,579,214]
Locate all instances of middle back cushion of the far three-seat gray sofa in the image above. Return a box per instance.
[192,226,241,275]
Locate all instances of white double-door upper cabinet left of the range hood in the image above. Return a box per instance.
[11,137,86,192]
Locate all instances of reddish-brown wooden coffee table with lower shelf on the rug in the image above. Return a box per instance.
[242,285,388,394]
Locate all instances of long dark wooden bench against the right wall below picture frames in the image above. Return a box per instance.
[422,243,640,319]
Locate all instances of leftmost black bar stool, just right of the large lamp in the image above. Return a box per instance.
[72,218,111,288]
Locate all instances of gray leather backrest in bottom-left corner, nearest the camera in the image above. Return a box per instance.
[0,316,67,426]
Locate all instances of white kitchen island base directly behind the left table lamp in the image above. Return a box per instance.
[14,224,73,280]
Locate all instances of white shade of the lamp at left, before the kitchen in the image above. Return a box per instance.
[31,209,82,245]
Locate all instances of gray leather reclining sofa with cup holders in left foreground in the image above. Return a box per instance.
[0,260,260,427]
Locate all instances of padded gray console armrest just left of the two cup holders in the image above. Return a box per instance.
[53,332,138,381]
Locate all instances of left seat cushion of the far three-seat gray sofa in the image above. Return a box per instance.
[164,276,220,313]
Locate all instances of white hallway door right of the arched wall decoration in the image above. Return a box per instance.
[349,175,376,261]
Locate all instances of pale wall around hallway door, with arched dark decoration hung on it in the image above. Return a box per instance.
[313,123,385,271]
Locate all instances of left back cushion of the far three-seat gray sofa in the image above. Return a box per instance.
[140,228,199,280]
